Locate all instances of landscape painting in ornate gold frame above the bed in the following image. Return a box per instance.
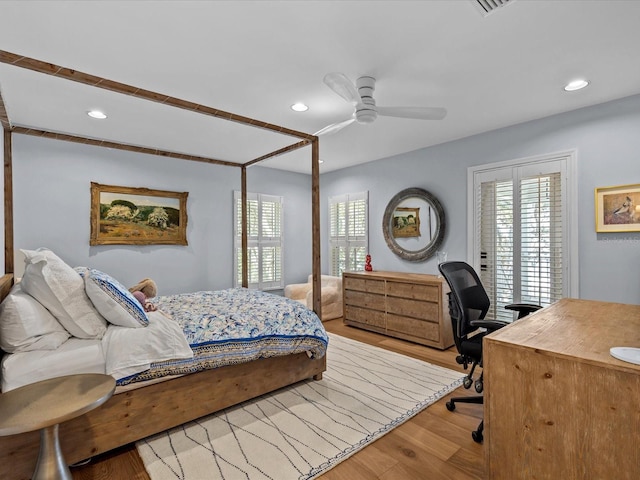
[89,182,188,245]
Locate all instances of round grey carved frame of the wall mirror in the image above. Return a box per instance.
[382,187,446,262]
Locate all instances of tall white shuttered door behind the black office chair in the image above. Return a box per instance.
[469,152,577,321]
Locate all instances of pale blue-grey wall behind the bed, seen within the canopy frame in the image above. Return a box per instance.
[13,135,311,294]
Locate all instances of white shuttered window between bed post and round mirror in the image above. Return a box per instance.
[329,192,369,276]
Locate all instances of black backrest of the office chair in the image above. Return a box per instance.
[438,262,491,345]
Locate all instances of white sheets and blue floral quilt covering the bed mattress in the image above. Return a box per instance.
[1,288,328,391]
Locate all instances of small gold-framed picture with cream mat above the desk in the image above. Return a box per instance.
[595,184,640,232]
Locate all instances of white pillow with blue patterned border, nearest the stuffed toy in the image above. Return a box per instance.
[75,267,149,328]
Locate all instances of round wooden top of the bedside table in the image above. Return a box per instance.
[0,373,116,436]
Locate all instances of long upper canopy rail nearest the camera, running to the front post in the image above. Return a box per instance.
[0,50,313,141]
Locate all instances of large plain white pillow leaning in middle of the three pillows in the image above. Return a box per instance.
[20,248,107,338]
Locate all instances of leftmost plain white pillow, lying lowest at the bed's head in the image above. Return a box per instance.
[0,284,70,353]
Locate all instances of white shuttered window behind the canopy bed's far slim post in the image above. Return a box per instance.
[233,191,284,290]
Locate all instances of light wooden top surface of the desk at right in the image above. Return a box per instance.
[485,298,640,372]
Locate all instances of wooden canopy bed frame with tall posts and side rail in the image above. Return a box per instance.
[0,50,326,478]
